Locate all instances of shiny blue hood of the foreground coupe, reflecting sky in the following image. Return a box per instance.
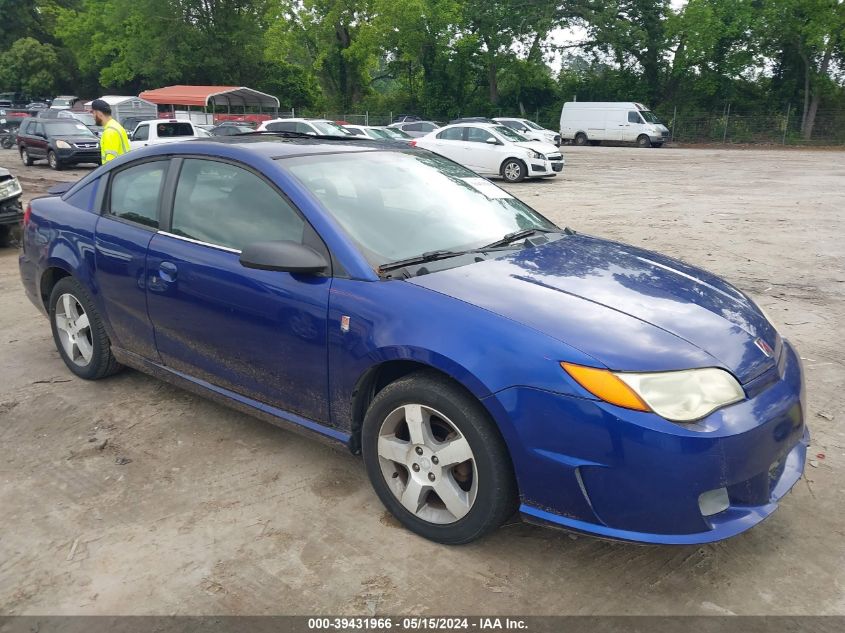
[409,235,780,383]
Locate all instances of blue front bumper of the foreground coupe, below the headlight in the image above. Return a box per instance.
[491,342,809,544]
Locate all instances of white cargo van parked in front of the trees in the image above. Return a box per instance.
[560,101,669,147]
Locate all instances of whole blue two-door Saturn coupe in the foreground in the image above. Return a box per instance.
[20,133,809,544]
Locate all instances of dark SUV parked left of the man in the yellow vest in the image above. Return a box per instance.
[18,118,100,170]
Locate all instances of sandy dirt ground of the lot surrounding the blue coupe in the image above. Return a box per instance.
[0,147,845,615]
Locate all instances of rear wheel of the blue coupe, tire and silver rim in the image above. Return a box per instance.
[49,277,121,380]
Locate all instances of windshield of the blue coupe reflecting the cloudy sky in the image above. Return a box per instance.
[279,150,557,268]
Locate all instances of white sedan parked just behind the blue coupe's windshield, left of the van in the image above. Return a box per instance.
[412,123,564,182]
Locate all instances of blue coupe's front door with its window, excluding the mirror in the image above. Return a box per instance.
[147,158,331,424]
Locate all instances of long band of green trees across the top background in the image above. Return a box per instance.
[0,0,845,138]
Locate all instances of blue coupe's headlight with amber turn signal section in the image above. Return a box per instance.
[561,363,745,422]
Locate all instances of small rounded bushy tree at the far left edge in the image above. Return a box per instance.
[0,37,61,96]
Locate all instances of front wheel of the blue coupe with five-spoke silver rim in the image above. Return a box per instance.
[361,372,517,545]
